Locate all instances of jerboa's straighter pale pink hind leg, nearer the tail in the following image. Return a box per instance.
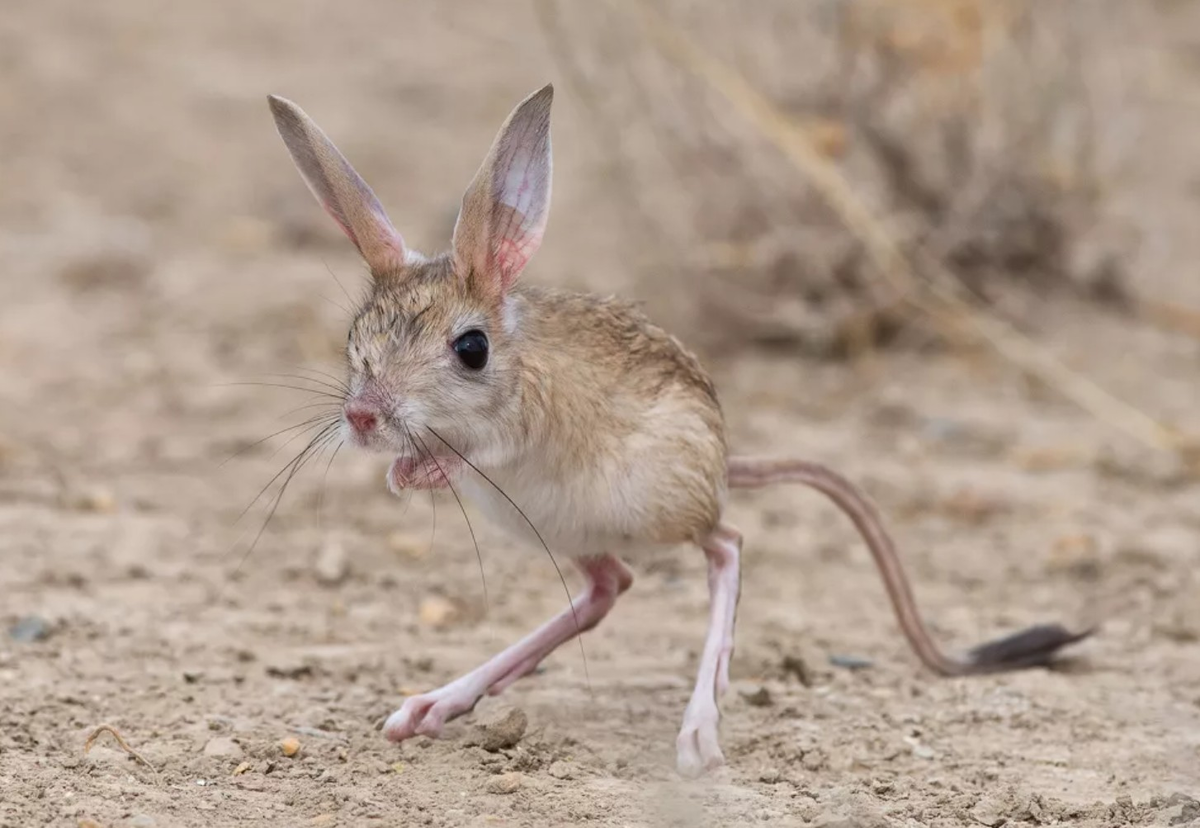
[676,523,742,776]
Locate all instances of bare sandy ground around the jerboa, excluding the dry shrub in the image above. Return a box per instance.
[0,0,1200,828]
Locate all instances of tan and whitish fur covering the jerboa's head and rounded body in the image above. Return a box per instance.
[348,256,726,554]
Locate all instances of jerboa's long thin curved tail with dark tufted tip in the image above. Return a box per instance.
[728,457,1094,676]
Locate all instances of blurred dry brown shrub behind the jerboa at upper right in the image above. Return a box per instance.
[539,0,1139,353]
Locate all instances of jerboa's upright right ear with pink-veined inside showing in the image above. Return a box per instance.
[454,84,554,295]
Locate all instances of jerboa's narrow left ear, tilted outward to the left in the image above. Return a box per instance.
[268,95,407,276]
